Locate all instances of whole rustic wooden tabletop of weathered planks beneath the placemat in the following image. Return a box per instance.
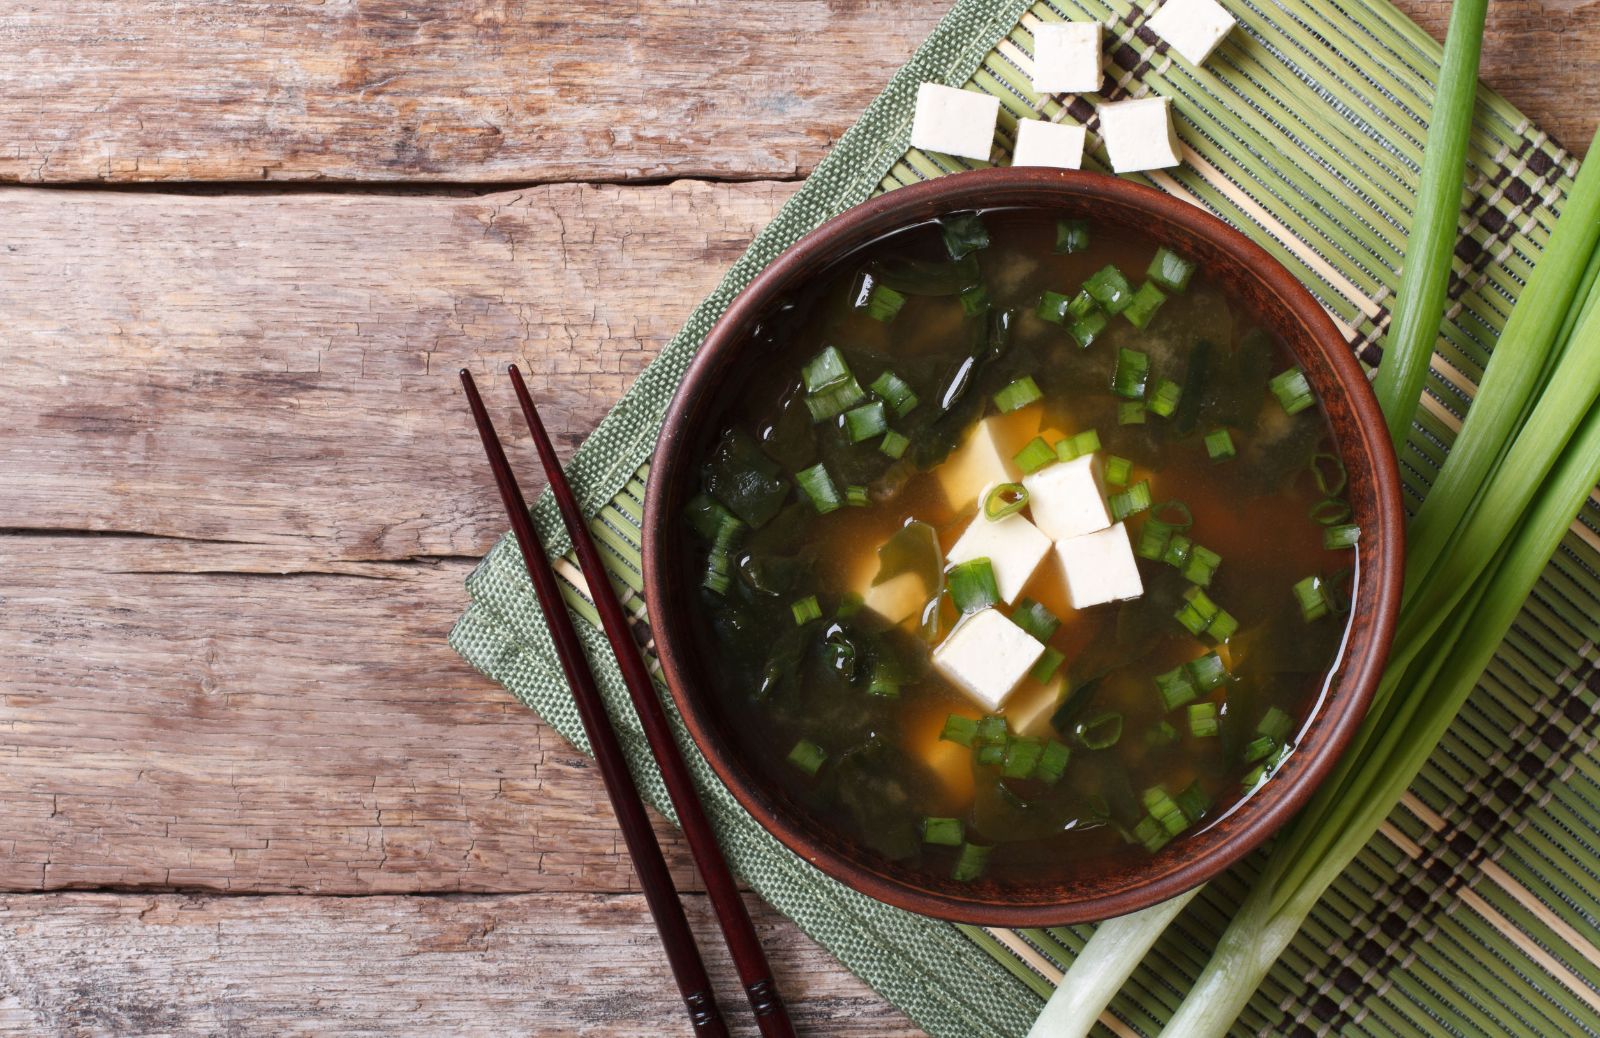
[0,0,1600,1035]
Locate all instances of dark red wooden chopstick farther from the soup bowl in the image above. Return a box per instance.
[461,368,728,1038]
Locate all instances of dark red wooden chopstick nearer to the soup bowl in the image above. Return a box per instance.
[509,365,795,1038]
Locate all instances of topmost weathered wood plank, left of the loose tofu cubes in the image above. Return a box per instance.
[0,0,949,182]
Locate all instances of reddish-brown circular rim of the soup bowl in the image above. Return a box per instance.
[643,168,1405,926]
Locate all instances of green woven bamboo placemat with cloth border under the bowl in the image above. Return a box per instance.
[451,0,1600,1038]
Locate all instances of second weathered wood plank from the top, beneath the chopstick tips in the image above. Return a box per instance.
[0,181,794,561]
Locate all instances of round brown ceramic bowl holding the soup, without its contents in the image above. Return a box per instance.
[645,170,1403,926]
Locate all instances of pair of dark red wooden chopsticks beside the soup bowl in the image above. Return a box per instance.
[461,365,795,1038]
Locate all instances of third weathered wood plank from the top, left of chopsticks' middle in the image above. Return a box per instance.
[0,536,713,894]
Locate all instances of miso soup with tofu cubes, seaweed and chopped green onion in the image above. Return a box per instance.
[682,210,1360,884]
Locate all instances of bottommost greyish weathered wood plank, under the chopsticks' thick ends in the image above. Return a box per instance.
[0,894,920,1038]
